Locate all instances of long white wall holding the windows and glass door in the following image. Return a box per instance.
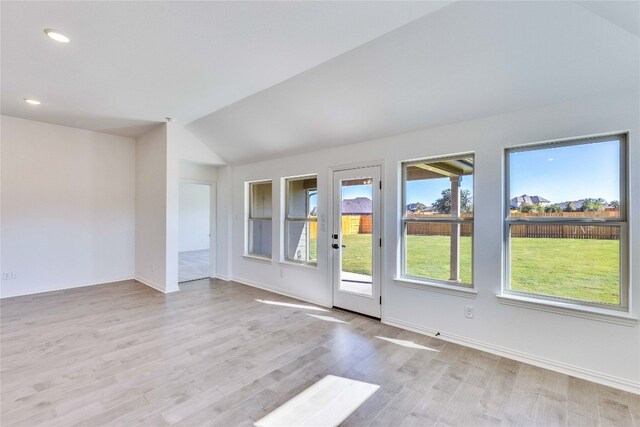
[228,93,640,390]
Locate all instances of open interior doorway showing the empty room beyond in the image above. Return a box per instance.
[178,182,215,283]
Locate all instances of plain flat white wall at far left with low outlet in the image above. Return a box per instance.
[0,116,135,297]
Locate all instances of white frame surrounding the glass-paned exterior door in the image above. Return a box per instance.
[327,159,386,320]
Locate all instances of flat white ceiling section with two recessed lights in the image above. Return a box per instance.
[1,1,447,135]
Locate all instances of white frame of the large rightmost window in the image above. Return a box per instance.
[500,133,630,313]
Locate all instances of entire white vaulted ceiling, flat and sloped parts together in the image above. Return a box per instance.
[1,1,640,163]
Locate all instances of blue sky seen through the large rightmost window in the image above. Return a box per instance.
[509,141,620,203]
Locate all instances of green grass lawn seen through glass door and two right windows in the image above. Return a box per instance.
[343,234,620,304]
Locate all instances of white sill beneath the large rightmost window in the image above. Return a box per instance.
[496,294,640,326]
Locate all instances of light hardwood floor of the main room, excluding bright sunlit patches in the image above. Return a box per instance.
[0,279,640,427]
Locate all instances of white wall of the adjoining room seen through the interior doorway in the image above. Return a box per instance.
[179,182,211,252]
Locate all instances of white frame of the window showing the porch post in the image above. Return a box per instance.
[396,153,476,294]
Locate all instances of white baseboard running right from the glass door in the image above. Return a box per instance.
[382,317,640,394]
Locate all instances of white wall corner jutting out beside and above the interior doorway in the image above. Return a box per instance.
[136,123,222,292]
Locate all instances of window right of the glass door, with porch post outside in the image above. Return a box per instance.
[402,154,473,287]
